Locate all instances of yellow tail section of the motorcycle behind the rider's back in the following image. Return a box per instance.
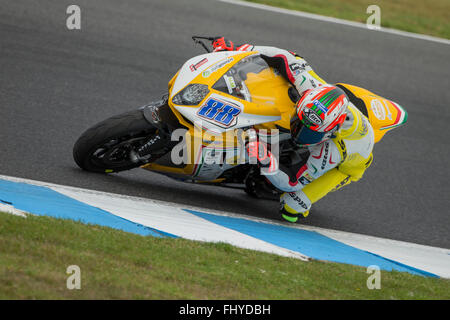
[339,83,408,143]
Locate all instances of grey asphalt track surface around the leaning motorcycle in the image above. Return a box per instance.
[0,0,450,248]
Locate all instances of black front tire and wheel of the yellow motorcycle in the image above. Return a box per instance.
[73,110,156,173]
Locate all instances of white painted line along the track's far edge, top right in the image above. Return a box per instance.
[218,0,450,45]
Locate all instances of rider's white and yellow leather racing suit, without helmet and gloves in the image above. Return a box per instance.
[237,44,374,222]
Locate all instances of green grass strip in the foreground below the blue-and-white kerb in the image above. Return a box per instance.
[0,213,450,300]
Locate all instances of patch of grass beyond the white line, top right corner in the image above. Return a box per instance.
[247,0,450,39]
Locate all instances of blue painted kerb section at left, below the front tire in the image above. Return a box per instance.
[0,180,176,237]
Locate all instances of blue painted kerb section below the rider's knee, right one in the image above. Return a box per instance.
[185,209,438,277]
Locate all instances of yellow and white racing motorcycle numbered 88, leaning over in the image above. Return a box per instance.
[73,36,407,199]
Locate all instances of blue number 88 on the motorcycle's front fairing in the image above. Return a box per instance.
[197,99,241,127]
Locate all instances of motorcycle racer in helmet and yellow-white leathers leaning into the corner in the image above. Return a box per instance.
[213,37,374,222]
